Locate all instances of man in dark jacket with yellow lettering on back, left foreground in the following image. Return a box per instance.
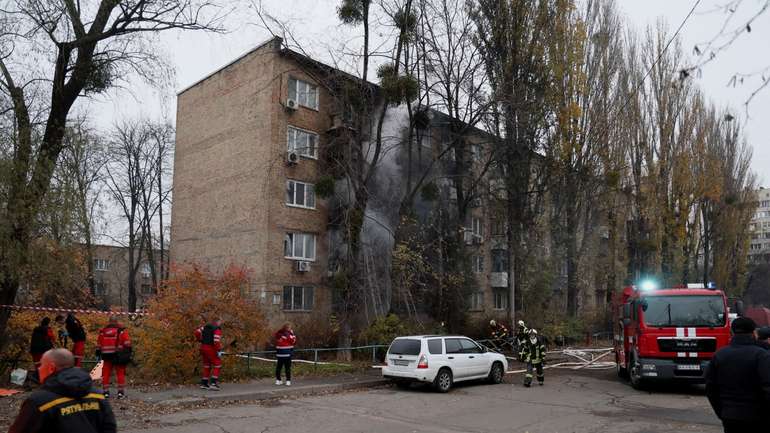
[8,349,117,433]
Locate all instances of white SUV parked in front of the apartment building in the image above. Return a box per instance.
[382,335,508,392]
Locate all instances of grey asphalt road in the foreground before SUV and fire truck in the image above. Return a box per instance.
[121,370,722,433]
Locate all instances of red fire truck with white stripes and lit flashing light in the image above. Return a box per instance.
[613,282,730,388]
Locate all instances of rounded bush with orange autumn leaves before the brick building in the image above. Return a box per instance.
[135,266,268,382]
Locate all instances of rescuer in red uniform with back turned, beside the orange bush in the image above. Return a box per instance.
[96,316,131,399]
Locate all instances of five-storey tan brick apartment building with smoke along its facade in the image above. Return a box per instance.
[171,38,608,323]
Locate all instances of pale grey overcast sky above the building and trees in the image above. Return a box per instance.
[81,0,770,186]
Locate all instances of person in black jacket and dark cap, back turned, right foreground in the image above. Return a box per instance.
[706,317,770,433]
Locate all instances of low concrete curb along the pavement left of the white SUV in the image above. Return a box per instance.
[154,378,391,405]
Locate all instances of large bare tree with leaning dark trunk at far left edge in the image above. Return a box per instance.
[0,0,226,345]
